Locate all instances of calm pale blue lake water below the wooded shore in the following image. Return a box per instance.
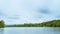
[0,27,60,34]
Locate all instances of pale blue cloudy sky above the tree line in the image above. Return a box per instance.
[0,0,60,24]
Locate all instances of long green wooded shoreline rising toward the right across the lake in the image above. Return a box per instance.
[7,20,60,27]
